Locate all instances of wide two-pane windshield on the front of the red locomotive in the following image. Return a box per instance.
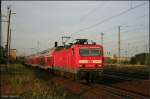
[79,48,101,56]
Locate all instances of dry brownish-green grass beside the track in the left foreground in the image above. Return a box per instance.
[1,64,78,99]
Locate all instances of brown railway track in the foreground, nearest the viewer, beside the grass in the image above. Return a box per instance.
[52,77,149,99]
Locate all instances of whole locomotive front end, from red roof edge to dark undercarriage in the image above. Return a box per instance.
[77,45,104,81]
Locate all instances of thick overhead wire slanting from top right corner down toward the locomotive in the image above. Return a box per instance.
[72,2,147,34]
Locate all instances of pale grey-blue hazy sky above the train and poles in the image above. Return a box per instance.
[1,1,149,57]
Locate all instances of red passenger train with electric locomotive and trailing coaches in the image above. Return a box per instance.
[25,39,104,82]
